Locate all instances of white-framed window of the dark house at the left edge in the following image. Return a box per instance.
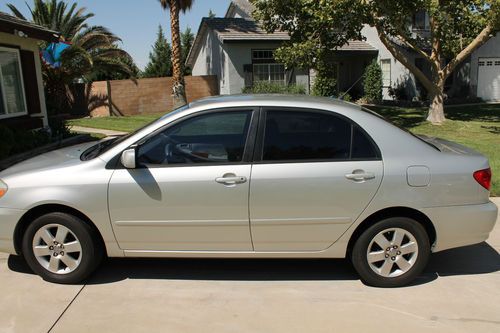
[0,47,27,118]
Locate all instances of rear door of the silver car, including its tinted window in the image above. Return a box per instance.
[250,108,383,251]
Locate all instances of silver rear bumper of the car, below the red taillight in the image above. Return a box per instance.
[421,202,498,252]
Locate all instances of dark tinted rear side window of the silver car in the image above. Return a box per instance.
[262,111,378,161]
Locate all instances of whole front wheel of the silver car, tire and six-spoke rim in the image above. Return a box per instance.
[22,213,102,283]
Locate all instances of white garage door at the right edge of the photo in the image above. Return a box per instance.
[477,57,500,101]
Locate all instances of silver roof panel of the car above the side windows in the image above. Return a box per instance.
[189,94,361,110]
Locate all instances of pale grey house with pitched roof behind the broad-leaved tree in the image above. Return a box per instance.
[187,0,500,100]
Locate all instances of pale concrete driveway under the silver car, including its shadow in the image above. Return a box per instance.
[0,199,500,333]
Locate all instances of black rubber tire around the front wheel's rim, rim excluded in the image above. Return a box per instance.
[22,212,104,284]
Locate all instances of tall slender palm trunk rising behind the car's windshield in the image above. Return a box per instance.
[159,0,194,108]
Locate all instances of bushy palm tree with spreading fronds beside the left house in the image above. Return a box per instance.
[7,0,133,112]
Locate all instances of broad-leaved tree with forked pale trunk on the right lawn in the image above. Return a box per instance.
[253,0,500,123]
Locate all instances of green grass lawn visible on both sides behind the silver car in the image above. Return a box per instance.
[69,104,500,196]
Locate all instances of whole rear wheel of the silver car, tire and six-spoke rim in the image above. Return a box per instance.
[351,217,430,287]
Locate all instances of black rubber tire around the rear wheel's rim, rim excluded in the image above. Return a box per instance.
[351,217,431,288]
